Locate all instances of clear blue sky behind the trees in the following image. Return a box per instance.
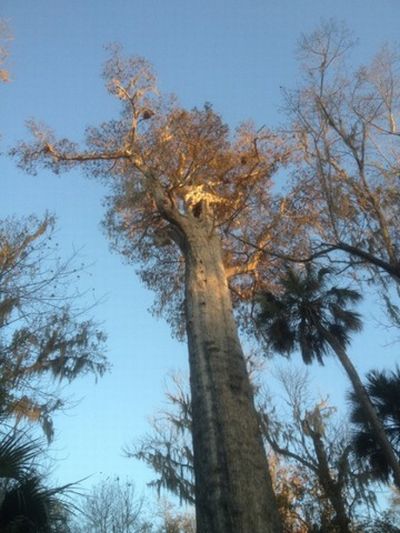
[0,0,400,502]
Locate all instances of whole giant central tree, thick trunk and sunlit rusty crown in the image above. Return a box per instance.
[12,50,289,533]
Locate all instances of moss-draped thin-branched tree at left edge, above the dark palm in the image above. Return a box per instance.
[0,216,107,439]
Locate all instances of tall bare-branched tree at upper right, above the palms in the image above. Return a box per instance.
[286,21,400,287]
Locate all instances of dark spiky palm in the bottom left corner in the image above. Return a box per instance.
[0,433,72,533]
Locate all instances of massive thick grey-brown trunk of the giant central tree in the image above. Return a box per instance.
[181,224,282,533]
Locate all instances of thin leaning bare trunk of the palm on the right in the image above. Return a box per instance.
[324,330,400,488]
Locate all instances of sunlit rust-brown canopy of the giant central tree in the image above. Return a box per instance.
[12,48,294,333]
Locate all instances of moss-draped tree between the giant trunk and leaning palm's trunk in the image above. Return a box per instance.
[260,369,375,533]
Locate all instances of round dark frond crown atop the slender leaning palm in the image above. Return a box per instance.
[257,264,362,364]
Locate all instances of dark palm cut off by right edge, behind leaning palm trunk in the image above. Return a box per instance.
[349,367,400,481]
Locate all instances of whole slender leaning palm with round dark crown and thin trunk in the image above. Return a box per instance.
[256,265,400,487]
